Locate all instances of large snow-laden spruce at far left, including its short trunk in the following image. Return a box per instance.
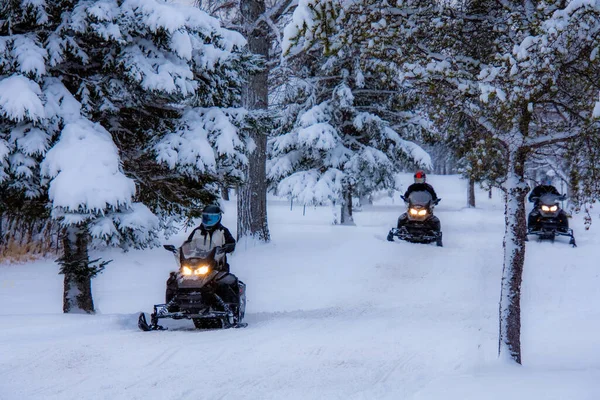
[0,0,253,311]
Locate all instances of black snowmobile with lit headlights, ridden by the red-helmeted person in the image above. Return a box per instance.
[387,191,443,247]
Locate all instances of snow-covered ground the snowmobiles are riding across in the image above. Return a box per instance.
[0,175,600,400]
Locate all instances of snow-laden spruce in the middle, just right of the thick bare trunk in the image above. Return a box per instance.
[268,0,432,223]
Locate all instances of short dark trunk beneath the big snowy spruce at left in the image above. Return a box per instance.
[61,226,94,313]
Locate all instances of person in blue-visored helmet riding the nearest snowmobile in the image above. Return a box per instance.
[166,205,239,303]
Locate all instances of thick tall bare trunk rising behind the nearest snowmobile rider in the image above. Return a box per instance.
[237,0,270,242]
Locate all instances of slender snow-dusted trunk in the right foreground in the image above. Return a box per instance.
[498,148,529,364]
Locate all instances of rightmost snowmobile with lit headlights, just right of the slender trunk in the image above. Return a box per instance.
[527,193,577,247]
